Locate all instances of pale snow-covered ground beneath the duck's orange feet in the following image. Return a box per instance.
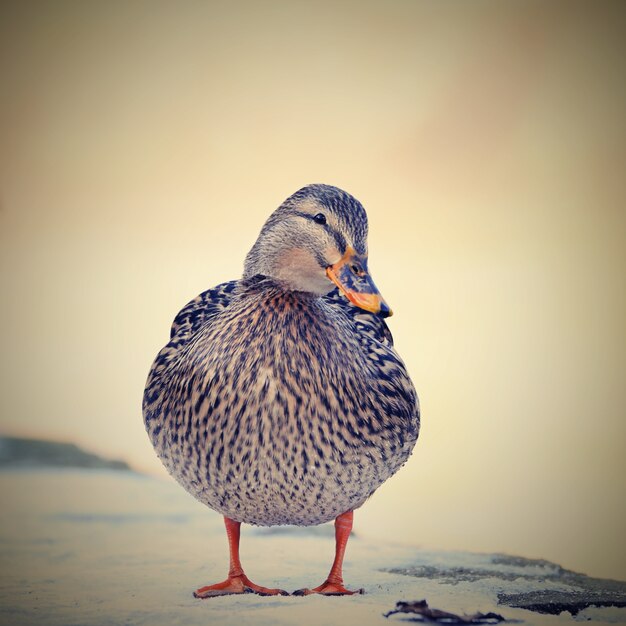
[0,469,626,626]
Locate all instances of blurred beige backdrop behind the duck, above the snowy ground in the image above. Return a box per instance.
[0,0,626,579]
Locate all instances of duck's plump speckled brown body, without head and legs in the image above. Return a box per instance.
[144,280,419,525]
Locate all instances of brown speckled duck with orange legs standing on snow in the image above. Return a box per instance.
[143,184,420,598]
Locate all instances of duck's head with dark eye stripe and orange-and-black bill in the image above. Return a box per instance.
[244,185,391,317]
